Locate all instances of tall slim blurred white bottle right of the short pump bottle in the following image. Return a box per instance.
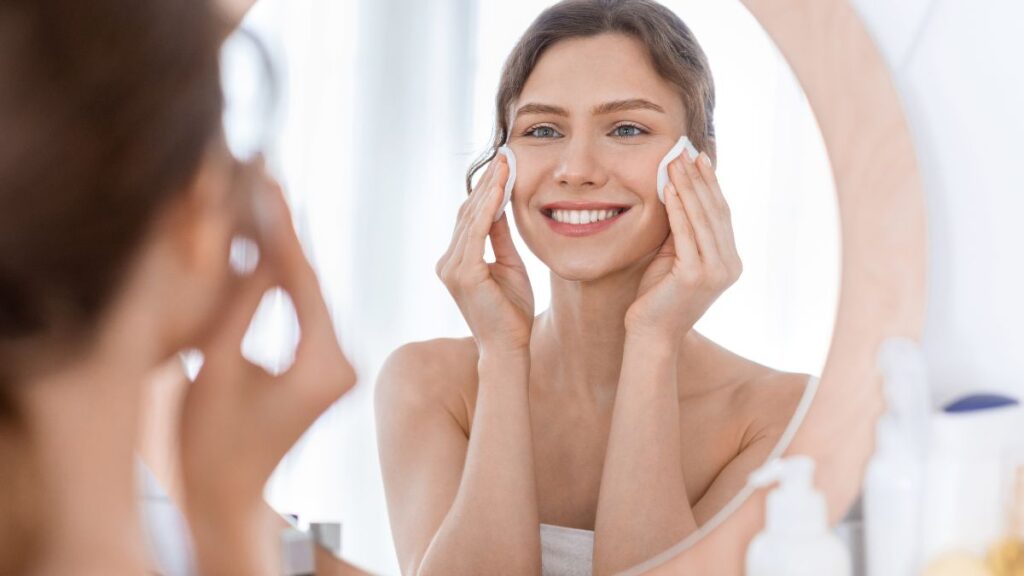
[863,338,931,576]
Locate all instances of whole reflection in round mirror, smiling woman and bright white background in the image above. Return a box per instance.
[232,0,839,573]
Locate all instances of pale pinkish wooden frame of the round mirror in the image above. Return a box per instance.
[626,0,927,576]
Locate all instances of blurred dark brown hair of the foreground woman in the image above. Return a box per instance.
[0,0,224,573]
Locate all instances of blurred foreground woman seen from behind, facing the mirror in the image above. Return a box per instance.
[0,0,354,574]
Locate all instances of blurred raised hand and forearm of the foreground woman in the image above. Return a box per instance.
[179,178,356,574]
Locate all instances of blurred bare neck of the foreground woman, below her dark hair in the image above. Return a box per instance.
[23,301,167,574]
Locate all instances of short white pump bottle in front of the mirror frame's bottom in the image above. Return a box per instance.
[746,456,851,576]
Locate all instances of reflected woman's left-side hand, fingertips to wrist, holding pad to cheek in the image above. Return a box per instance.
[436,155,534,352]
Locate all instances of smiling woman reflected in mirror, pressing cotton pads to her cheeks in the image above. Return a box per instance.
[377,0,807,575]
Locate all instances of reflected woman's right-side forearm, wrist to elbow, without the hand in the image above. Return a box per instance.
[594,336,696,574]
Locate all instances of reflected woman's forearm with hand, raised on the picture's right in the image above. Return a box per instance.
[594,154,741,574]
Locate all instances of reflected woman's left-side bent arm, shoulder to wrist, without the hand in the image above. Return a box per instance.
[377,346,540,575]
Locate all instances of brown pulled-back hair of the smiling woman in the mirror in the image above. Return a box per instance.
[466,0,717,191]
